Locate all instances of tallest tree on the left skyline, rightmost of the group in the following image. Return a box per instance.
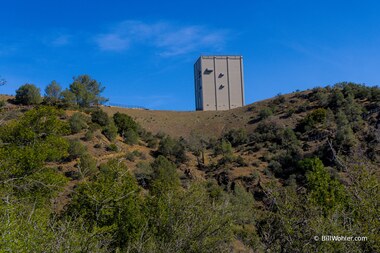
[70,75,107,107]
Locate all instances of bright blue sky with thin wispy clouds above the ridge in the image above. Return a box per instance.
[0,0,380,110]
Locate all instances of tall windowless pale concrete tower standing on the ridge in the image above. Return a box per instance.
[194,56,244,111]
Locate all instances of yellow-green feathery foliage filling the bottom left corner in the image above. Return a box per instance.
[0,204,110,253]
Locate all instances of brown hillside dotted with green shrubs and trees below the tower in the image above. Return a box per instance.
[0,83,380,252]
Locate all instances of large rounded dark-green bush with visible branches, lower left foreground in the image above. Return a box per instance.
[67,160,145,251]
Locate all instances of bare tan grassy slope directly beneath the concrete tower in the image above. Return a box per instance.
[102,91,300,139]
